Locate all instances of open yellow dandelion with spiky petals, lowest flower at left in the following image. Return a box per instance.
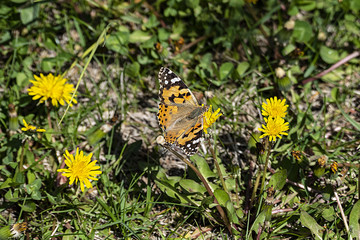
[57,148,102,192]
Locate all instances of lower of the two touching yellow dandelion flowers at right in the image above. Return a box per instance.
[259,117,289,142]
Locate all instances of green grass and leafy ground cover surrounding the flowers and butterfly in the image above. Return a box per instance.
[0,0,360,239]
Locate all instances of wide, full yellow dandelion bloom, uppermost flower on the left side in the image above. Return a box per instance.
[28,73,77,107]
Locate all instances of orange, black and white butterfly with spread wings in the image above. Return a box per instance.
[157,67,207,156]
